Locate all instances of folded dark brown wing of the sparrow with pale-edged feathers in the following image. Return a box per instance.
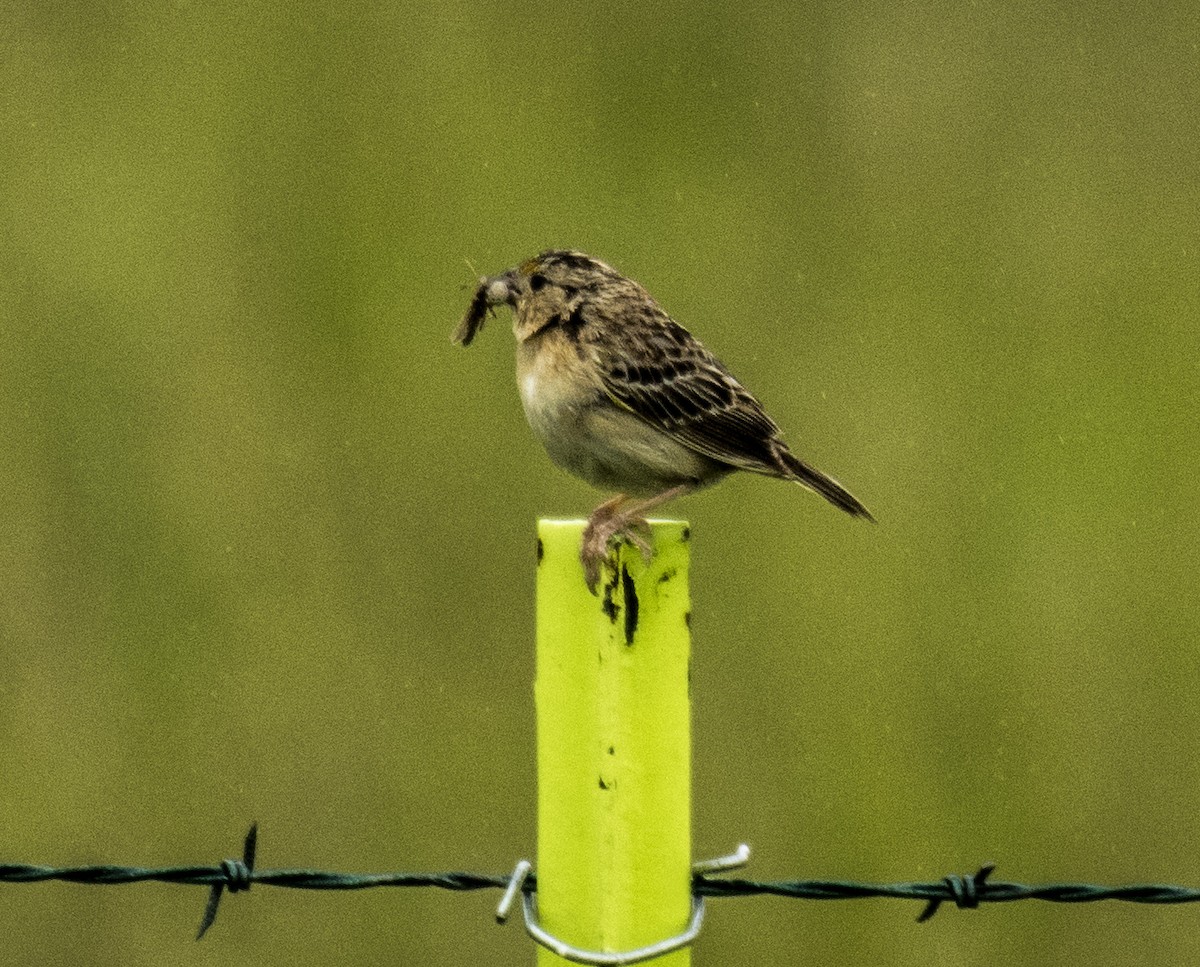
[595,313,785,476]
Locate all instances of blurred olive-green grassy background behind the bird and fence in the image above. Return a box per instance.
[0,0,1200,967]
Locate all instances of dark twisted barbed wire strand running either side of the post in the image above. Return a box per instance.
[0,824,1200,939]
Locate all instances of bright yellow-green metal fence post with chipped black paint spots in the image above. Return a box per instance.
[534,521,691,967]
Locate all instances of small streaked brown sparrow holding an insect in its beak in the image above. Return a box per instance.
[452,250,875,594]
